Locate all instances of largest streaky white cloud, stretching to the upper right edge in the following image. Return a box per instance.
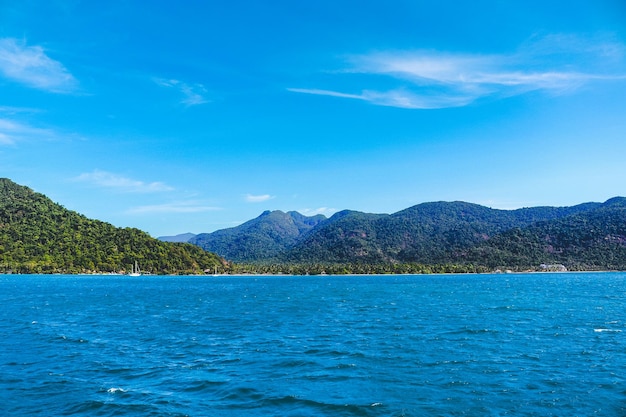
[288,35,626,109]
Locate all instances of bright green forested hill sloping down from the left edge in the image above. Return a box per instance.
[0,178,226,274]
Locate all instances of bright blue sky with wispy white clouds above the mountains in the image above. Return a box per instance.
[0,0,626,237]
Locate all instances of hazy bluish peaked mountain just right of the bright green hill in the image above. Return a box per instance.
[189,210,326,262]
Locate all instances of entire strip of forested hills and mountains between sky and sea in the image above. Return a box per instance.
[0,179,626,274]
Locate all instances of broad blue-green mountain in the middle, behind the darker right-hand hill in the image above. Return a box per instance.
[284,202,597,264]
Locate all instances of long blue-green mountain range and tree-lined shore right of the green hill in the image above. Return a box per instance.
[191,198,626,274]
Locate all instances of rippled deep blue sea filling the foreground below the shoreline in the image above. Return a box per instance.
[0,272,626,416]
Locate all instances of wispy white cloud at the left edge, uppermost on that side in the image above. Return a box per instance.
[0,38,78,93]
